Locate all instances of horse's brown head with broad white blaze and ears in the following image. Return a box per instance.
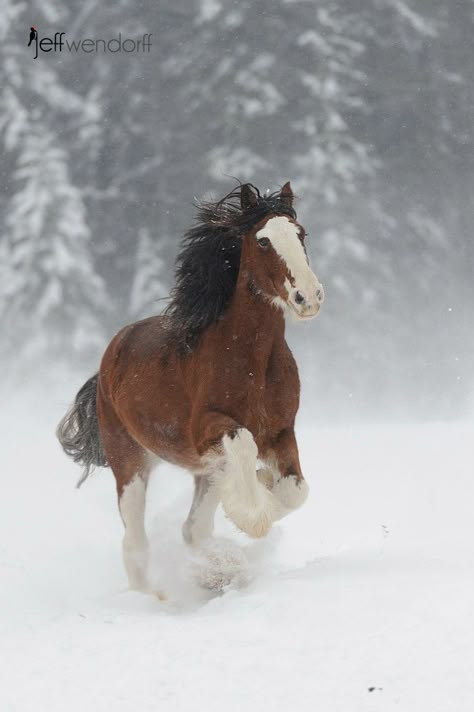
[241,182,324,319]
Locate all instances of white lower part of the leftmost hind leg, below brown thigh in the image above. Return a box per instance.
[119,475,148,591]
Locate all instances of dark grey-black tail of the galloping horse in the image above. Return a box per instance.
[56,373,107,487]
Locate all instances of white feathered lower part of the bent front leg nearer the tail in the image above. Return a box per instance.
[217,428,281,537]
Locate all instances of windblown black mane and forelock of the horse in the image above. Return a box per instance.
[164,183,296,351]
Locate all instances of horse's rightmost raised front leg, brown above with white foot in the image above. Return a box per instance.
[258,428,309,519]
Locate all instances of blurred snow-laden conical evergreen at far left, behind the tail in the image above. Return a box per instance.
[0,124,108,370]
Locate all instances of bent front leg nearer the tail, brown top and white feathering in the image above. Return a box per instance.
[193,411,285,537]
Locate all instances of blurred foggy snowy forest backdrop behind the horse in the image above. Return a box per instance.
[0,0,474,421]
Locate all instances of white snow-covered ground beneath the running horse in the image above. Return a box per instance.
[0,400,474,712]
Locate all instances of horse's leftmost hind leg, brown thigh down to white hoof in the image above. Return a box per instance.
[97,400,151,591]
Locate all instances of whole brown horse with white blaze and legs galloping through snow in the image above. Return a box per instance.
[58,183,324,590]
